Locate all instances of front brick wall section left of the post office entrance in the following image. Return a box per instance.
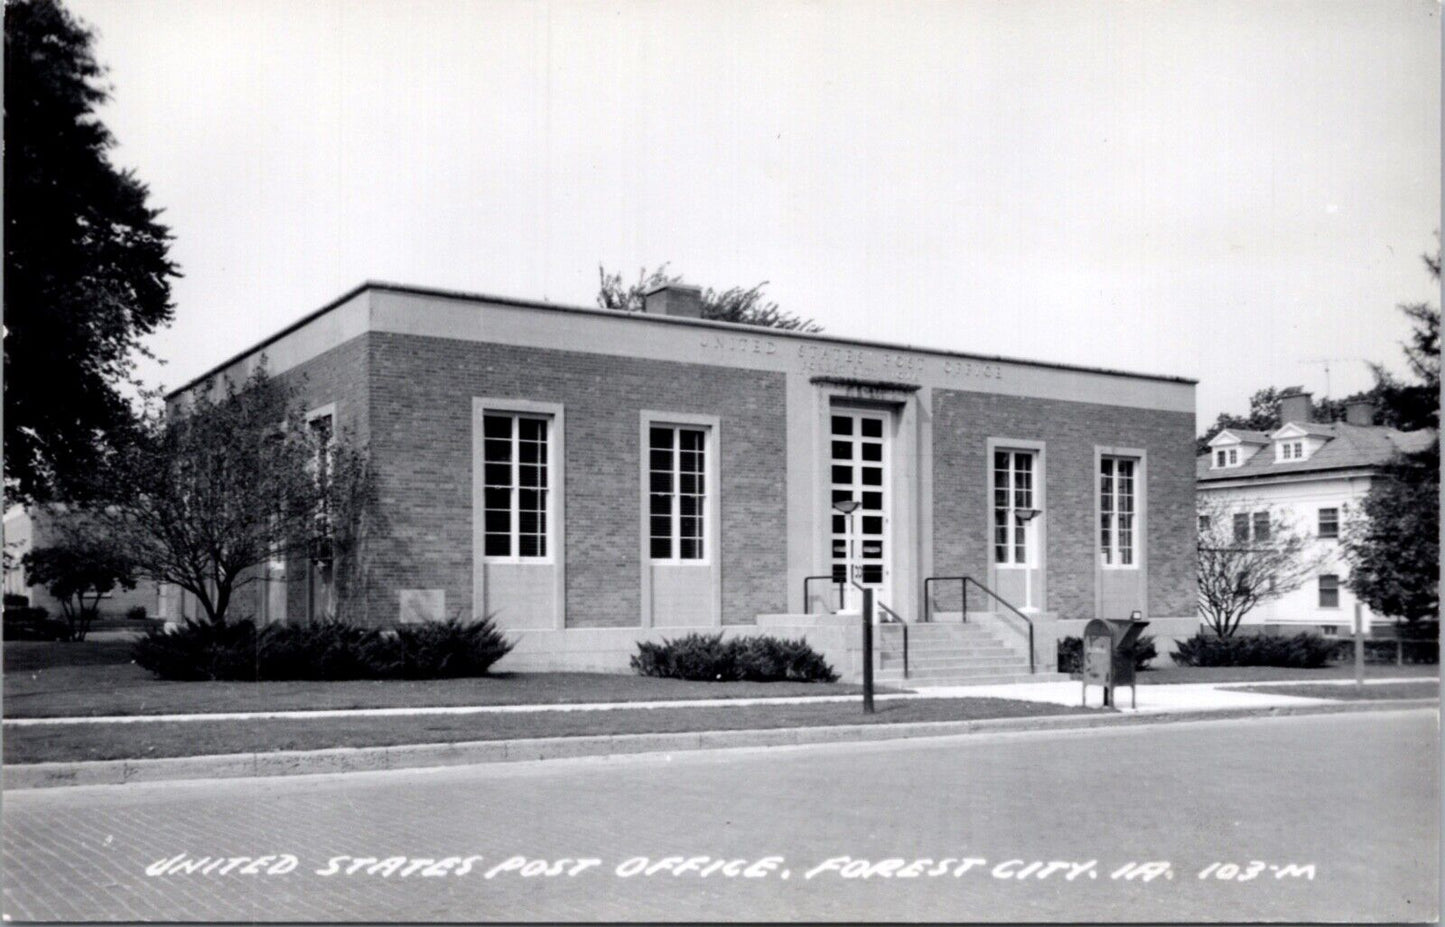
[368,332,786,627]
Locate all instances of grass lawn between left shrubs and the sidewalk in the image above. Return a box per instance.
[4,641,890,719]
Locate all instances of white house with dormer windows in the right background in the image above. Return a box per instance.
[1196,388,1433,634]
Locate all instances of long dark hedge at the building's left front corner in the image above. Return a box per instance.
[133,618,513,682]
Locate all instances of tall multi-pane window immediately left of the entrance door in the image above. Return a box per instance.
[647,425,708,560]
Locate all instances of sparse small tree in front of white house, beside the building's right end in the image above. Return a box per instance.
[1198,495,1328,637]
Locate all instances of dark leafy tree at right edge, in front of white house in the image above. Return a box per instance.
[1341,438,1441,622]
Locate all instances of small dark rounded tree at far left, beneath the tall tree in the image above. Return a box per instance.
[22,522,136,641]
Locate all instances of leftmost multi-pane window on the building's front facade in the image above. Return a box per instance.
[481,412,552,560]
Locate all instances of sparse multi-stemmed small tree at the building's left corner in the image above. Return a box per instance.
[74,367,374,624]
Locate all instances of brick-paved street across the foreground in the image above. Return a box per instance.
[4,709,1439,921]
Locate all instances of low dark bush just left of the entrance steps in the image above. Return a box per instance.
[631,634,838,683]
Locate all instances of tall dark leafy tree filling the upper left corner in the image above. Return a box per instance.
[4,0,179,500]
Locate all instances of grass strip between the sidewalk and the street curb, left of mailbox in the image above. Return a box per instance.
[4,699,1098,764]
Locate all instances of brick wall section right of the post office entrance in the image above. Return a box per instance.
[933,390,1195,619]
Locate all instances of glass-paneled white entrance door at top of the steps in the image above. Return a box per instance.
[828,409,893,611]
